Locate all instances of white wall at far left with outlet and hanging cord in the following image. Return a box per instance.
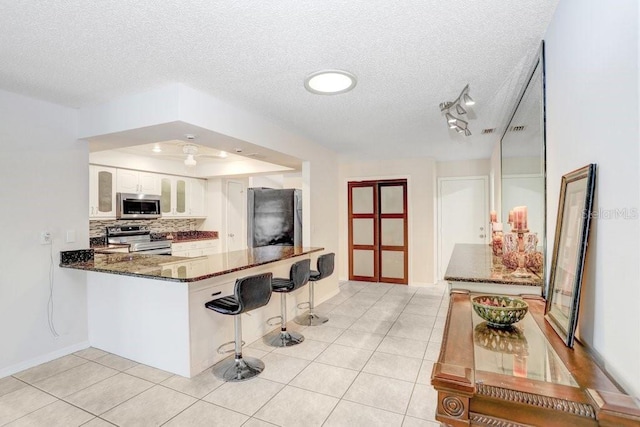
[0,91,89,378]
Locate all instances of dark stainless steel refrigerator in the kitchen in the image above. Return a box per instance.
[247,188,302,248]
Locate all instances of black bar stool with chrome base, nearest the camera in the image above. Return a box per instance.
[204,273,273,382]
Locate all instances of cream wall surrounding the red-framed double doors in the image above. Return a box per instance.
[338,158,436,285]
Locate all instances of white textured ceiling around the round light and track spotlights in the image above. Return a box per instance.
[0,0,558,160]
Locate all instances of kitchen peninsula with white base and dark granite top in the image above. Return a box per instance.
[60,246,323,377]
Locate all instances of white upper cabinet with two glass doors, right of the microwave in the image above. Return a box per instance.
[160,176,206,218]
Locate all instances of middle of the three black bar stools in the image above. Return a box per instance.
[264,259,311,347]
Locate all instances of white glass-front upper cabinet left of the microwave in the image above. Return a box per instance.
[89,165,116,218]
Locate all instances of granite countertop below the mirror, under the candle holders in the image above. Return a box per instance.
[444,243,543,286]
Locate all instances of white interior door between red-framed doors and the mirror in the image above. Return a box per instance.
[438,176,489,279]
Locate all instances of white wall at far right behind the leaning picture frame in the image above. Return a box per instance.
[545,0,640,396]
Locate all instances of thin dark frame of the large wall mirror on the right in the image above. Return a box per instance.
[500,40,549,298]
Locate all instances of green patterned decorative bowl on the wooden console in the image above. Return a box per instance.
[471,295,529,328]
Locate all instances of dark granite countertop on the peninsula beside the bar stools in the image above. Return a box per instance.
[60,246,324,282]
